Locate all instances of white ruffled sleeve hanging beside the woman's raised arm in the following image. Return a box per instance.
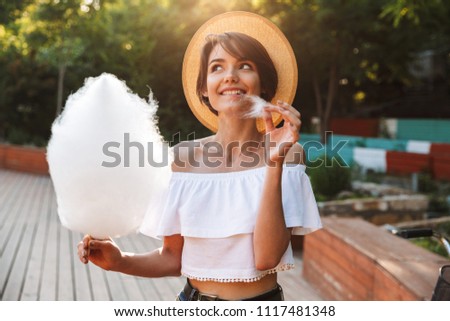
[282,165,322,235]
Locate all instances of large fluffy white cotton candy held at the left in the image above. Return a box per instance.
[47,74,172,238]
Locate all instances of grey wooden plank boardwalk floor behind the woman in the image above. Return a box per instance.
[0,169,321,301]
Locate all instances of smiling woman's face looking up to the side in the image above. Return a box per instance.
[203,45,261,113]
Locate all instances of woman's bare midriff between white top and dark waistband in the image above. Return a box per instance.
[189,273,277,300]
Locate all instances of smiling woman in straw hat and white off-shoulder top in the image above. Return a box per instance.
[78,12,321,301]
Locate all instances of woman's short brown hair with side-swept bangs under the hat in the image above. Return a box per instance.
[197,32,278,115]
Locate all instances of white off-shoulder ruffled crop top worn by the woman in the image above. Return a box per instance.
[140,165,322,282]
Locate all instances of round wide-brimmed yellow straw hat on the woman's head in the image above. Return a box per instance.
[182,11,298,132]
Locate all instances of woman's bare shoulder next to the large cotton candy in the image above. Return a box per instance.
[172,137,214,172]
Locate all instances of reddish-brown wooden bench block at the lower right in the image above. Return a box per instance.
[303,217,450,300]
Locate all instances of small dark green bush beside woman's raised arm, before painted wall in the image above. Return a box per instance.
[307,159,351,198]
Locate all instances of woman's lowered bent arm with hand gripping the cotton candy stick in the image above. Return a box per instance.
[78,234,183,277]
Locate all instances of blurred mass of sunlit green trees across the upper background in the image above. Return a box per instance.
[0,0,450,145]
